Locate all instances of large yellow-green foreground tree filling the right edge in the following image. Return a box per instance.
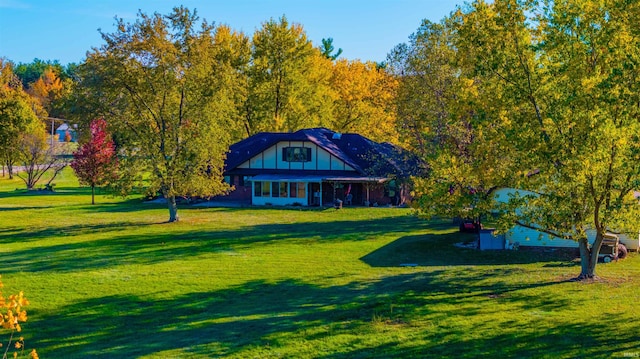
[404,0,640,279]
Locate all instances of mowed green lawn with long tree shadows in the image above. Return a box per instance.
[0,171,640,358]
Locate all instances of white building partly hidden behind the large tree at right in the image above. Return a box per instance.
[494,188,640,251]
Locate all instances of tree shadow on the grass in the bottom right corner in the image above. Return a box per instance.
[318,316,640,359]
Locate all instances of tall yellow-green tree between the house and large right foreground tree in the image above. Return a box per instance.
[388,19,512,225]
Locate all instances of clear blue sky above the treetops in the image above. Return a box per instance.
[0,0,462,64]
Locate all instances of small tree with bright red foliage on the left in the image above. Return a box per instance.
[70,119,118,204]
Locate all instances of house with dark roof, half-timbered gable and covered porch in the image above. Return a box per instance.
[224,128,422,206]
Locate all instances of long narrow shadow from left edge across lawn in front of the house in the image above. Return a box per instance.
[0,216,427,274]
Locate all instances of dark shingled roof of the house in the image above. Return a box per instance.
[225,128,423,177]
